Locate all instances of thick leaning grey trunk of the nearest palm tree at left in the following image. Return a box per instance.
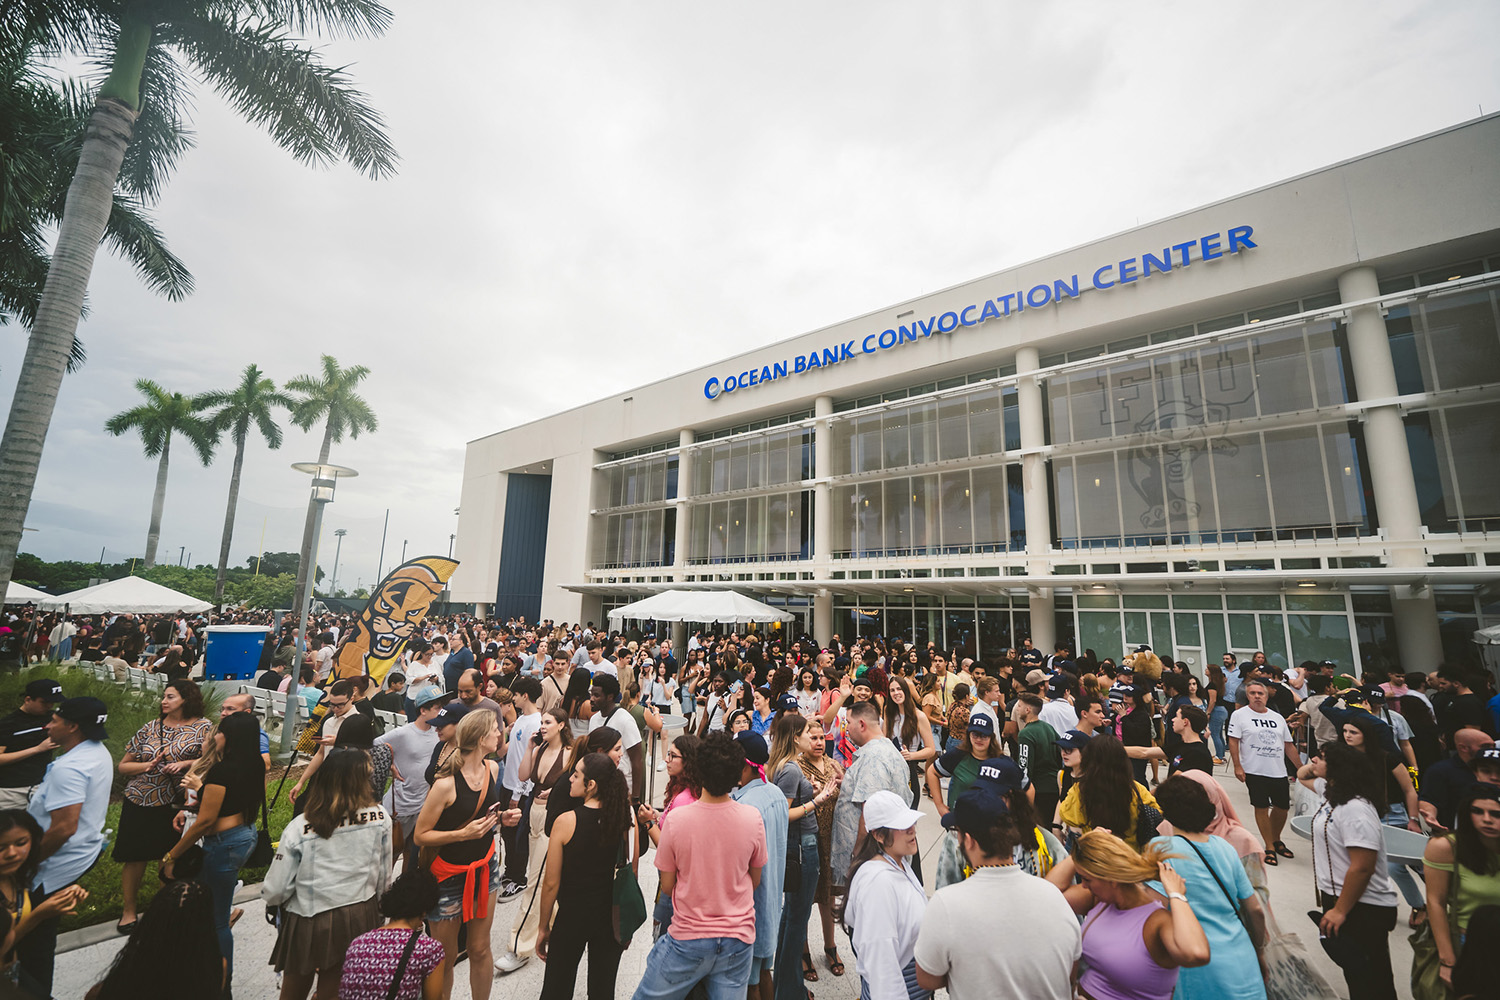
[0,25,152,592]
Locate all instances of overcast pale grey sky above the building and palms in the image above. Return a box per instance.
[0,0,1500,588]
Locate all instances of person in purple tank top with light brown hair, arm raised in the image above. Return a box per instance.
[1047,829,1209,1000]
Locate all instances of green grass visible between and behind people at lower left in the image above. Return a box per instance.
[0,666,294,931]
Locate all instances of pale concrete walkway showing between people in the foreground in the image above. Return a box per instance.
[54,766,1412,1000]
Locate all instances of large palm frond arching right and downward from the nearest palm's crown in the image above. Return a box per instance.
[159,15,398,178]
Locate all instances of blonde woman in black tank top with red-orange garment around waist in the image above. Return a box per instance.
[411,712,521,1000]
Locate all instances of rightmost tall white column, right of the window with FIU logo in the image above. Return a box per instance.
[1338,267,1443,670]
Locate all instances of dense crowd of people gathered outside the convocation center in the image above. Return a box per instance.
[0,616,1500,1000]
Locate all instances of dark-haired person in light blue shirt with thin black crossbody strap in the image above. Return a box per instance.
[1152,775,1266,1000]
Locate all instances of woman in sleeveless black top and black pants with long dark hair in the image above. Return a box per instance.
[537,754,633,1000]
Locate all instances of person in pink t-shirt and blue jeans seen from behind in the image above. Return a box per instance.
[635,732,767,1000]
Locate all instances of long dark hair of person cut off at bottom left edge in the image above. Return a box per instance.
[90,881,219,1000]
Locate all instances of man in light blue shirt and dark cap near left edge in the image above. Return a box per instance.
[17,697,114,997]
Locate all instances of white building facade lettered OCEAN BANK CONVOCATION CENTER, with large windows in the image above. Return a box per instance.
[452,115,1500,680]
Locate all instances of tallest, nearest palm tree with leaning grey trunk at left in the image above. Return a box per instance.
[0,0,396,599]
